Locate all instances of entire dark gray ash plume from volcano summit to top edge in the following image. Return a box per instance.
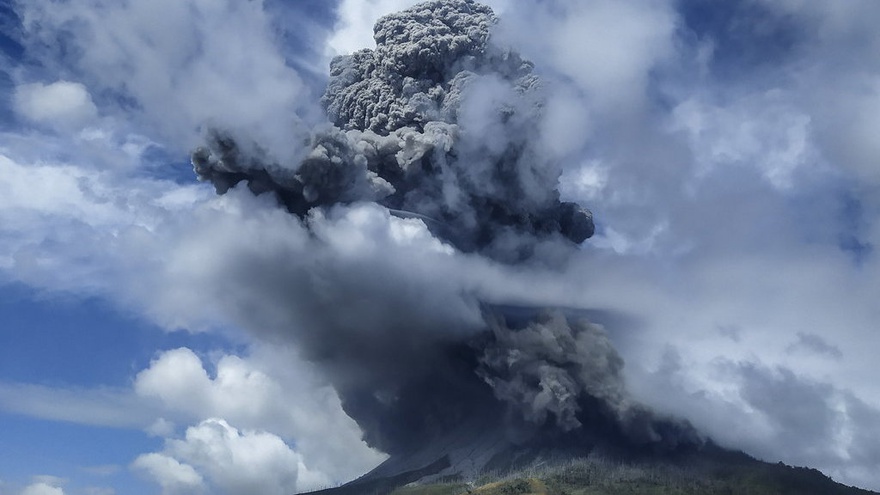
[192,0,700,484]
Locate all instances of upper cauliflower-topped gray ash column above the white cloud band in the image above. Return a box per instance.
[192,0,593,261]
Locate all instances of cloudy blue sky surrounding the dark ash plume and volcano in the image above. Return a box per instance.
[0,0,880,495]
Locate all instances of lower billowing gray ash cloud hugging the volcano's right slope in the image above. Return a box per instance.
[477,308,701,449]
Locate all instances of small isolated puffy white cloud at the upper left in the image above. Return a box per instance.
[14,81,98,127]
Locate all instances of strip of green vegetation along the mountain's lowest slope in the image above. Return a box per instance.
[392,458,873,495]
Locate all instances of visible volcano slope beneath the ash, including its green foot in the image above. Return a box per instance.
[312,443,876,495]
